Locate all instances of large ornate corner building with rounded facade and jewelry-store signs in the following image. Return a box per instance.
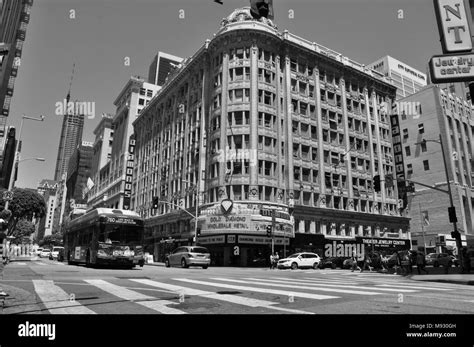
[131,7,410,266]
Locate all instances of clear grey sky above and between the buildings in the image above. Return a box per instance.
[8,0,442,187]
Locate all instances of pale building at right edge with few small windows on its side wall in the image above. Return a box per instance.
[395,85,474,251]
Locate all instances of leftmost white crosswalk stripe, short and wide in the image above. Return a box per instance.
[33,280,95,314]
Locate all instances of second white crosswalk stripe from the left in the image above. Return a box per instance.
[85,280,186,314]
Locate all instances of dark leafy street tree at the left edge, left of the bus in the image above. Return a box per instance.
[0,188,46,236]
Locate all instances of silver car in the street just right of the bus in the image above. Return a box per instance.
[165,246,211,269]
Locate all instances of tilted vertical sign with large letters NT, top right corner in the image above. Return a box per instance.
[434,0,472,54]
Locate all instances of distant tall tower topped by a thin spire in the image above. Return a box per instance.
[54,105,84,181]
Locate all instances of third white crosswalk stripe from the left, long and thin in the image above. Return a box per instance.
[131,279,309,314]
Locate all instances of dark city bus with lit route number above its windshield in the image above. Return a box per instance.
[64,208,145,268]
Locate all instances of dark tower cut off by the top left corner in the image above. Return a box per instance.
[0,0,33,155]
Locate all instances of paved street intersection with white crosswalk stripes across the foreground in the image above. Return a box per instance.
[0,259,474,314]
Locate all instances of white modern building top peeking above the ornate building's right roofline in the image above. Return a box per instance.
[367,55,427,99]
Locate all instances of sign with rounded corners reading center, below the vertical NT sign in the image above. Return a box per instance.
[430,53,474,83]
